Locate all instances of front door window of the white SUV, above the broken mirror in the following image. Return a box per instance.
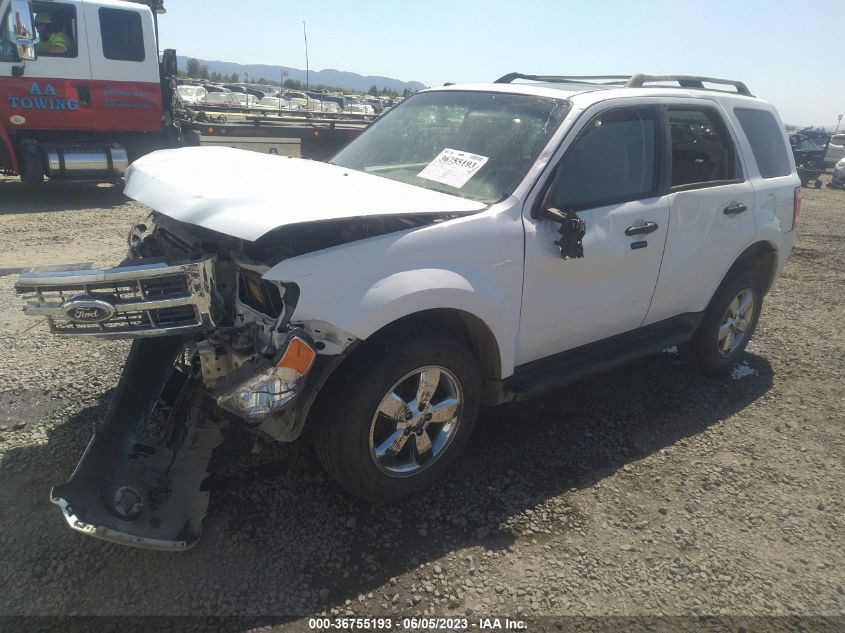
[543,107,657,210]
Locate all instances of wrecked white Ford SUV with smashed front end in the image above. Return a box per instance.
[17,74,800,549]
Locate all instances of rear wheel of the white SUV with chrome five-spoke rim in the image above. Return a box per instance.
[679,270,763,374]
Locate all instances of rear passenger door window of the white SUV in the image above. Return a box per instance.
[668,107,737,187]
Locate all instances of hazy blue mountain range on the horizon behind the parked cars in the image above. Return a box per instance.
[176,55,426,94]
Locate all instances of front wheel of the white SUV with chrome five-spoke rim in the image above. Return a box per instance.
[314,336,481,501]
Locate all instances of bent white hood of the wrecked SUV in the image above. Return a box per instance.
[125,147,486,241]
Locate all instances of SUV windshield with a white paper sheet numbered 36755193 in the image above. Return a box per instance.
[331,90,569,203]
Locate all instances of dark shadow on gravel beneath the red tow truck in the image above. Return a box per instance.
[0,180,127,215]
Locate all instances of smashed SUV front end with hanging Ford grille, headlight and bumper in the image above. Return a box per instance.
[16,216,330,550]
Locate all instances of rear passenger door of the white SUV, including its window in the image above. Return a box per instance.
[644,100,756,325]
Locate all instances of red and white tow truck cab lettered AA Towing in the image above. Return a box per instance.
[0,0,166,183]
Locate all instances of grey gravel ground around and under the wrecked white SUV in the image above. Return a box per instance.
[0,173,845,628]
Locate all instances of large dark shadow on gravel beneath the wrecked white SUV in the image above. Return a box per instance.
[0,346,772,616]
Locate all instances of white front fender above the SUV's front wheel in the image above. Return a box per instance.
[264,203,523,377]
